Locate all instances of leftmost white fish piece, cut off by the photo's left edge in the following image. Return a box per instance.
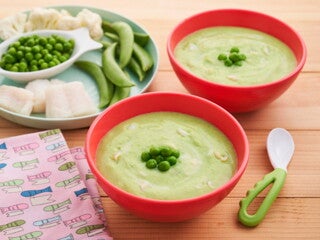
[0,85,34,115]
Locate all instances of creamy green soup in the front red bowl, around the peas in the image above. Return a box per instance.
[97,112,237,200]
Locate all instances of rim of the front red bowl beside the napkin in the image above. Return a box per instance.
[84,91,249,205]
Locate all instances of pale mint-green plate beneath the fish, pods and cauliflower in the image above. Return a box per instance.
[0,6,159,129]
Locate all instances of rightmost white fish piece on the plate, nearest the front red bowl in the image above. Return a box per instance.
[46,81,98,118]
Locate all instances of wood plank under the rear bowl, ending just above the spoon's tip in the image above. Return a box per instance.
[148,71,320,130]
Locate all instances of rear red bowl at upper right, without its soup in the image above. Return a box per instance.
[167,9,306,112]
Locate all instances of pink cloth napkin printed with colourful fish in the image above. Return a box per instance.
[0,129,112,240]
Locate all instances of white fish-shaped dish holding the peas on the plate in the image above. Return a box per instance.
[0,28,102,83]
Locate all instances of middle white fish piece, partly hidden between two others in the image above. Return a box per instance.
[25,79,64,113]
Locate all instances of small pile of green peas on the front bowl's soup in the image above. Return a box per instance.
[141,146,180,172]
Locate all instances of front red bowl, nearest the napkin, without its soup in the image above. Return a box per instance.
[85,92,249,222]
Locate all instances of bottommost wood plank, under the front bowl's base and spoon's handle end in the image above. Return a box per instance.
[103,198,320,240]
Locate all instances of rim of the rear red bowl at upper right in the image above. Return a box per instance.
[166,8,307,90]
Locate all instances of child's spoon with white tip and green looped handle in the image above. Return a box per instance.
[238,128,294,227]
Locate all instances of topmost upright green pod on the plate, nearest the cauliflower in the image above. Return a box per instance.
[111,21,134,68]
